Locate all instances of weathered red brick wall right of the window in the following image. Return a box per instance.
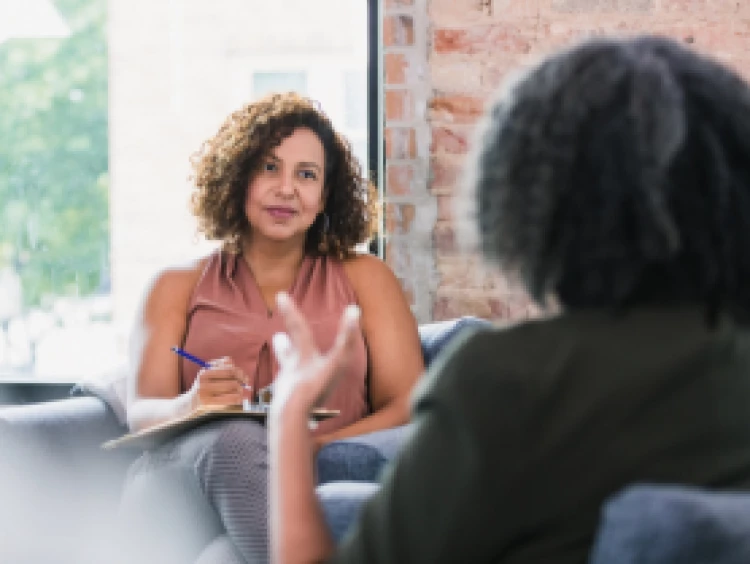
[383,0,750,321]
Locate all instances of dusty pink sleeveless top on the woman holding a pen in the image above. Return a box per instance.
[180,251,368,433]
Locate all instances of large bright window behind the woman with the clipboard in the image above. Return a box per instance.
[0,0,376,382]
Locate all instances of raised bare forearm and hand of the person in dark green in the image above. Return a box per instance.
[269,294,359,564]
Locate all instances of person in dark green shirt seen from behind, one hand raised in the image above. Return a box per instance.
[270,36,750,564]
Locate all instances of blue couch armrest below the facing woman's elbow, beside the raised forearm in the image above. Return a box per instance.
[316,425,411,484]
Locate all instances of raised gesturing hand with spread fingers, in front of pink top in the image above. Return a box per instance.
[271,293,359,417]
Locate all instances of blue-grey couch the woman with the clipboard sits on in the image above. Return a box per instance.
[0,317,488,564]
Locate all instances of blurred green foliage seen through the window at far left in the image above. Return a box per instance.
[0,0,109,306]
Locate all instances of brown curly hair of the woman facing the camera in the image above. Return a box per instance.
[191,92,376,259]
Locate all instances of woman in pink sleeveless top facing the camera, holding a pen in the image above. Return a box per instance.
[117,93,424,563]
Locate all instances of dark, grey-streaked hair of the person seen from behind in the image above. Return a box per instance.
[472,36,750,319]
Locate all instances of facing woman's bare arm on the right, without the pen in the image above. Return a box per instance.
[316,255,424,447]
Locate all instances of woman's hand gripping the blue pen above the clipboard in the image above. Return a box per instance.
[189,358,248,409]
